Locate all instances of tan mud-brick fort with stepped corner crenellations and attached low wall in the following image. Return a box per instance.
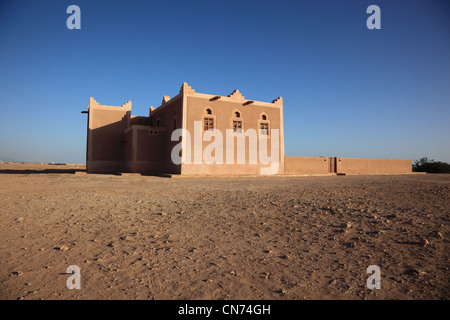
[84,83,411,175]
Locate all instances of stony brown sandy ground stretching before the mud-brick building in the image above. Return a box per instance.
[0,164,450,299]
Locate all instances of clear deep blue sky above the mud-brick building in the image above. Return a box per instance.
[0,0,450,163]
